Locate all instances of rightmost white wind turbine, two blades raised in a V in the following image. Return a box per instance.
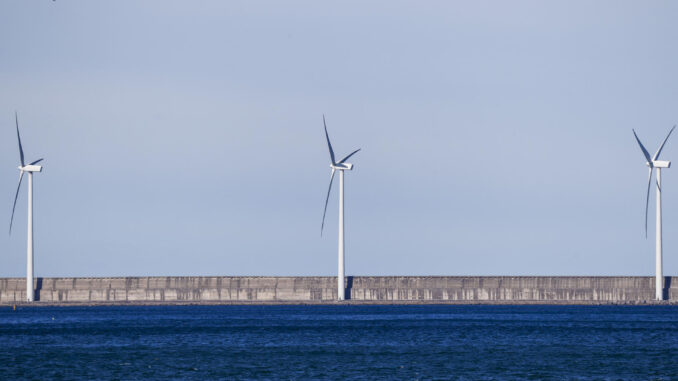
[632,126,676,300]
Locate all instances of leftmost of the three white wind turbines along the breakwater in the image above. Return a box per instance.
[9,112,43,302]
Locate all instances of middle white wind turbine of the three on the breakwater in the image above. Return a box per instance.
[320,115,360,300]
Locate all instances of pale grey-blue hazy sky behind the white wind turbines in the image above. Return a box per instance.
[0,0,678,277]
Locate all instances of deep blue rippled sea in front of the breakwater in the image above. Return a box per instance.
[0,306,678,380]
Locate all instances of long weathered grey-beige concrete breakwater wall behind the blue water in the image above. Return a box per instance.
[0,276,678,305]
